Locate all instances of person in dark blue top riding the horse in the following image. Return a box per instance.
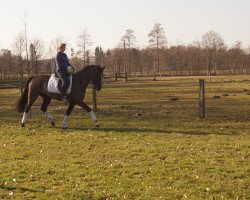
[56,43,72,101]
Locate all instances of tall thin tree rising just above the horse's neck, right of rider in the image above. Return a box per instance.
[77,29,92,66]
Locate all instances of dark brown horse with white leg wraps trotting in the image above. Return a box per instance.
[16,65,105,128]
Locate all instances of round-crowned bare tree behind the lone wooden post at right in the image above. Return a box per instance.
[200,31,224,80]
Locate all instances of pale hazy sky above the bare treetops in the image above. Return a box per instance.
[0,0,250,54]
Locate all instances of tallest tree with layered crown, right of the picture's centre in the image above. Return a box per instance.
[148,22,167,73]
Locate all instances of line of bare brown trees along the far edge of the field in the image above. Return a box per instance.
[0,22,250,83]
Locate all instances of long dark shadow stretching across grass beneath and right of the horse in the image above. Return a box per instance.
[65,127,234,135]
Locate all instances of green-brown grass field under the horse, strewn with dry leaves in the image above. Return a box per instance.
[0,76,250,199]
